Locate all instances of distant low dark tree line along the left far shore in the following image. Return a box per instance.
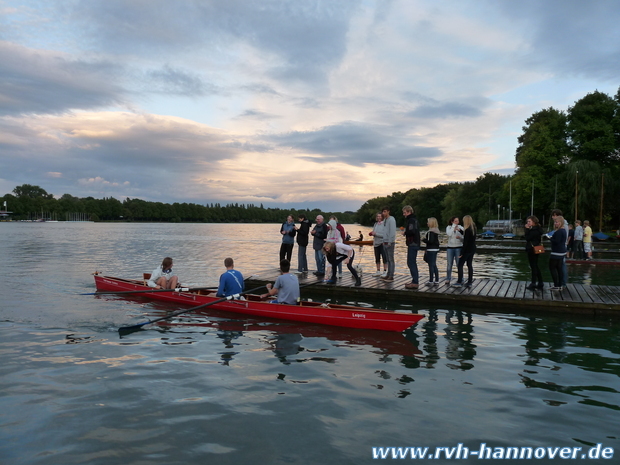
[0,184,355,223]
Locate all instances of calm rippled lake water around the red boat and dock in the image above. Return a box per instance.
[0,223,620,464]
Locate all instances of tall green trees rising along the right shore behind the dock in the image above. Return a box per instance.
[357,88,620,230]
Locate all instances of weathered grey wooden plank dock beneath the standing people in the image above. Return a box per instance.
[246,269,620,316]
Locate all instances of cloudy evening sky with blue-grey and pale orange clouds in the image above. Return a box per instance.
[0,0,620,211]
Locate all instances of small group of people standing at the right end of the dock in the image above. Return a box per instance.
[525,209,592,291]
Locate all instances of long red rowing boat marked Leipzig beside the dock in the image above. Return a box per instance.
[95,274,423,332]
